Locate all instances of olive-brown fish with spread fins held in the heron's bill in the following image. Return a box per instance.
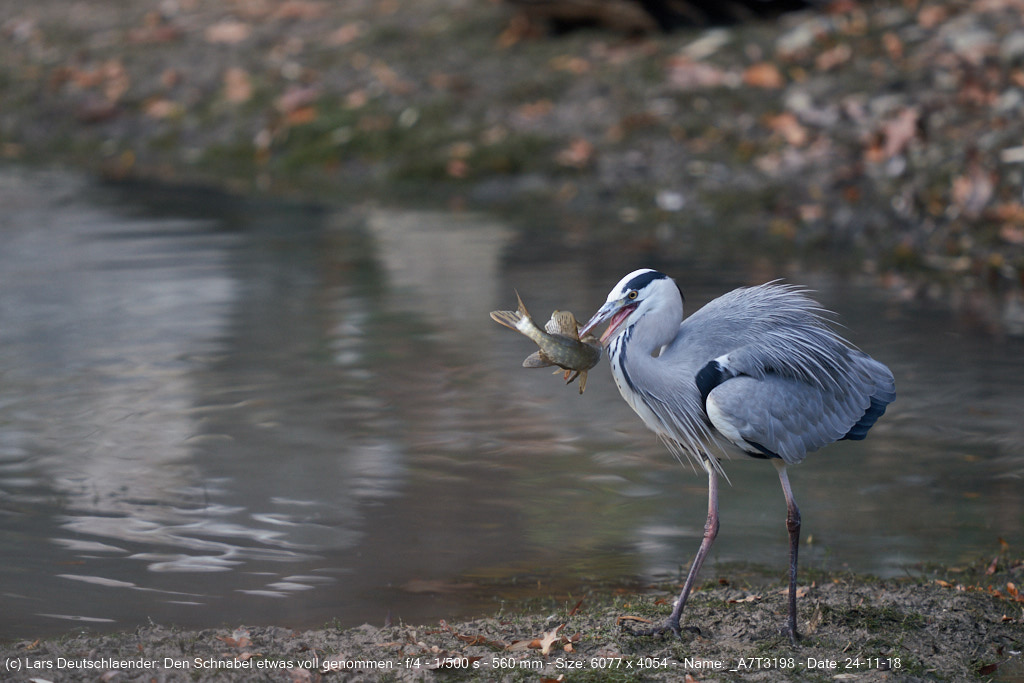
[490,292,601,393]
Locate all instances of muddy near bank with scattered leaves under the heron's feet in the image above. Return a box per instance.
[0,554,1024,681]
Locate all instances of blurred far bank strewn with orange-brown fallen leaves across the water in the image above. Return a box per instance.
[6,0,1024,334]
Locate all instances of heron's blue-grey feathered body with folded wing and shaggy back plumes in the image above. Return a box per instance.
[624,284,895,462]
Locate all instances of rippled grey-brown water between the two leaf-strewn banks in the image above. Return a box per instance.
[0,170,1024,637]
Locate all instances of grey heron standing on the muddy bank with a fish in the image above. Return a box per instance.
[581,268,896,642]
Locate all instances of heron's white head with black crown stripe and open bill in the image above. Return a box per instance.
[580,268,683,343]
